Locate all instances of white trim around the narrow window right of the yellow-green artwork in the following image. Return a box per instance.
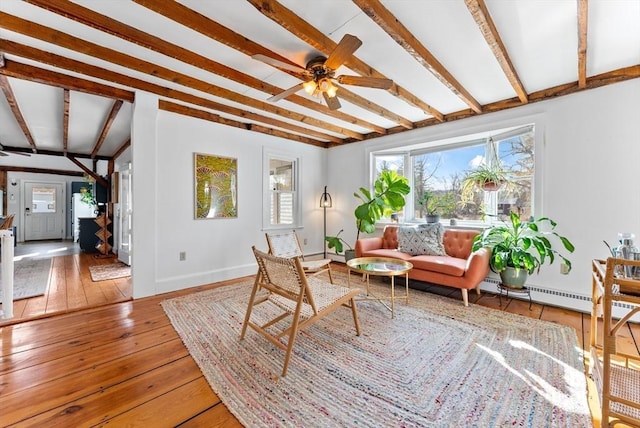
[262,148,302,230]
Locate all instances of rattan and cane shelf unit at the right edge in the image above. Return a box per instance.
[590,258,640,427]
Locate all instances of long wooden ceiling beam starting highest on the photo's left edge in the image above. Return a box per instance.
[0,12,362,139]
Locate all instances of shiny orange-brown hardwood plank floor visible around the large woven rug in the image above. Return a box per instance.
[0,260,640,427]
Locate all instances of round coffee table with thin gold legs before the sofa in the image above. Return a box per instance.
[347,257,413,318]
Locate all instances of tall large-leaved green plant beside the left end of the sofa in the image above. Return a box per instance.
[324,170,411,260]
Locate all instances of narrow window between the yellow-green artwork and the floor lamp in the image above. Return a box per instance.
[265,153,299,228]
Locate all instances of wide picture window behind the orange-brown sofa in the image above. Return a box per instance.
[373,125,534,224]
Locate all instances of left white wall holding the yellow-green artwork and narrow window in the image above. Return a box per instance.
[132,94,327,298]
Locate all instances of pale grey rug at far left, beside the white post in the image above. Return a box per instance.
[0,258,52,303]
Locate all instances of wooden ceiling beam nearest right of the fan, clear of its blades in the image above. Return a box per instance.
[353,0,482,113]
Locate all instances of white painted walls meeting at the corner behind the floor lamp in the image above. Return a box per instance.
[94,79,640,311]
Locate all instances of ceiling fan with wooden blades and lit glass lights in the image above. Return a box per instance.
[252,34,393,110]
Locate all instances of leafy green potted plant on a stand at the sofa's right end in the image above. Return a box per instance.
[473,212,575,288]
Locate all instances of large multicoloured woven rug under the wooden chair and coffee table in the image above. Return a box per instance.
[162,276,591,427]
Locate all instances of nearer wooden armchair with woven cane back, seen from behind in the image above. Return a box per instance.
[240,247,360,376]
